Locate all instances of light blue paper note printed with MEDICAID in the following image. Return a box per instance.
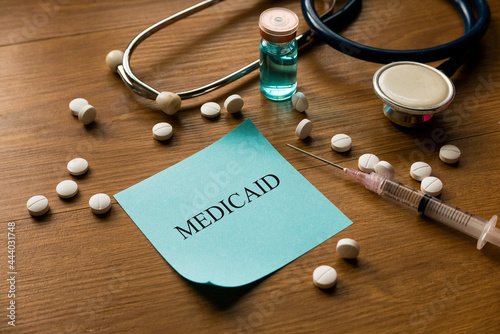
[114,119,352,287]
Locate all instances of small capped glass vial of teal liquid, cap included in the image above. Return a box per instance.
[259,8,299,101]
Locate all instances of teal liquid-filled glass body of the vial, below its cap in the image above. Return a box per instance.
[260,39,297,101]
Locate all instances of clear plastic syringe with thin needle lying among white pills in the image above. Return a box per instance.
[286,144,500,249]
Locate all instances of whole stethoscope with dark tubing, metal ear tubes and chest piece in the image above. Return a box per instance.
[106,0,490,127]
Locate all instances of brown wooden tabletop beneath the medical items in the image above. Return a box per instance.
[0,0,500,333]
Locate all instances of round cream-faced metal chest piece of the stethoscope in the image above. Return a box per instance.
[373,61,455,127]
